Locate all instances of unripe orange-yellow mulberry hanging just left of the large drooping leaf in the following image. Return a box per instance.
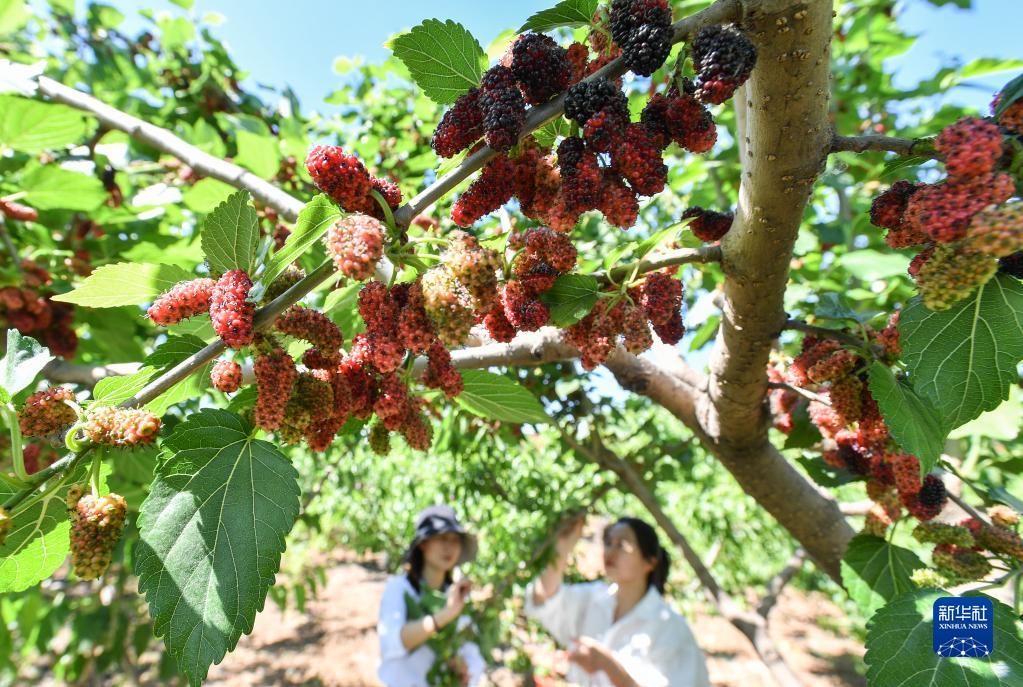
[68,486,128,580]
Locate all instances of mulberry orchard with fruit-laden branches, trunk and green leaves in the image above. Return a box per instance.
[0,0,1023,687]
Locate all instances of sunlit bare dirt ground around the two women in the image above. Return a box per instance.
[205,559,865,687]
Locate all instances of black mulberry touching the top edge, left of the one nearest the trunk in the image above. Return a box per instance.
[609,0,672,77]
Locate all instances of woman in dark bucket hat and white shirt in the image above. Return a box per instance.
[376,506,484,687]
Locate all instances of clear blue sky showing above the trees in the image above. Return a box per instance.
[48,0,1023,109]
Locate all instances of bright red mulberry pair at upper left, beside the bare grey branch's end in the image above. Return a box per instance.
[306,145,401,219]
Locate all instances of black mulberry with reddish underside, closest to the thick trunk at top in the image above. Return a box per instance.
[693,26,757,104]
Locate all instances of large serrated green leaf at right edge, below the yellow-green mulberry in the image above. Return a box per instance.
[898,275,1023,429]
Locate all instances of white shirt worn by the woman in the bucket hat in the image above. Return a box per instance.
[376,575,484,687]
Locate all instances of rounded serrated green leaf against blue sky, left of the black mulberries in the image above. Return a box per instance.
[392,19,486,105]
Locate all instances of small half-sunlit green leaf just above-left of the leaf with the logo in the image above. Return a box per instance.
[842,535,924,617]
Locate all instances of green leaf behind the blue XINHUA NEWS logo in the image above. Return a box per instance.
[863,589,1023,687]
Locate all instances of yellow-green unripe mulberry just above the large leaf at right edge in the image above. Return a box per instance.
[916,245,998,311]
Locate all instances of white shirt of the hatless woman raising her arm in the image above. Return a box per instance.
[526,582,710,687]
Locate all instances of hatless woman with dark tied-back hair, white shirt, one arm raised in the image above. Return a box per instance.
[526,517,710,687]
